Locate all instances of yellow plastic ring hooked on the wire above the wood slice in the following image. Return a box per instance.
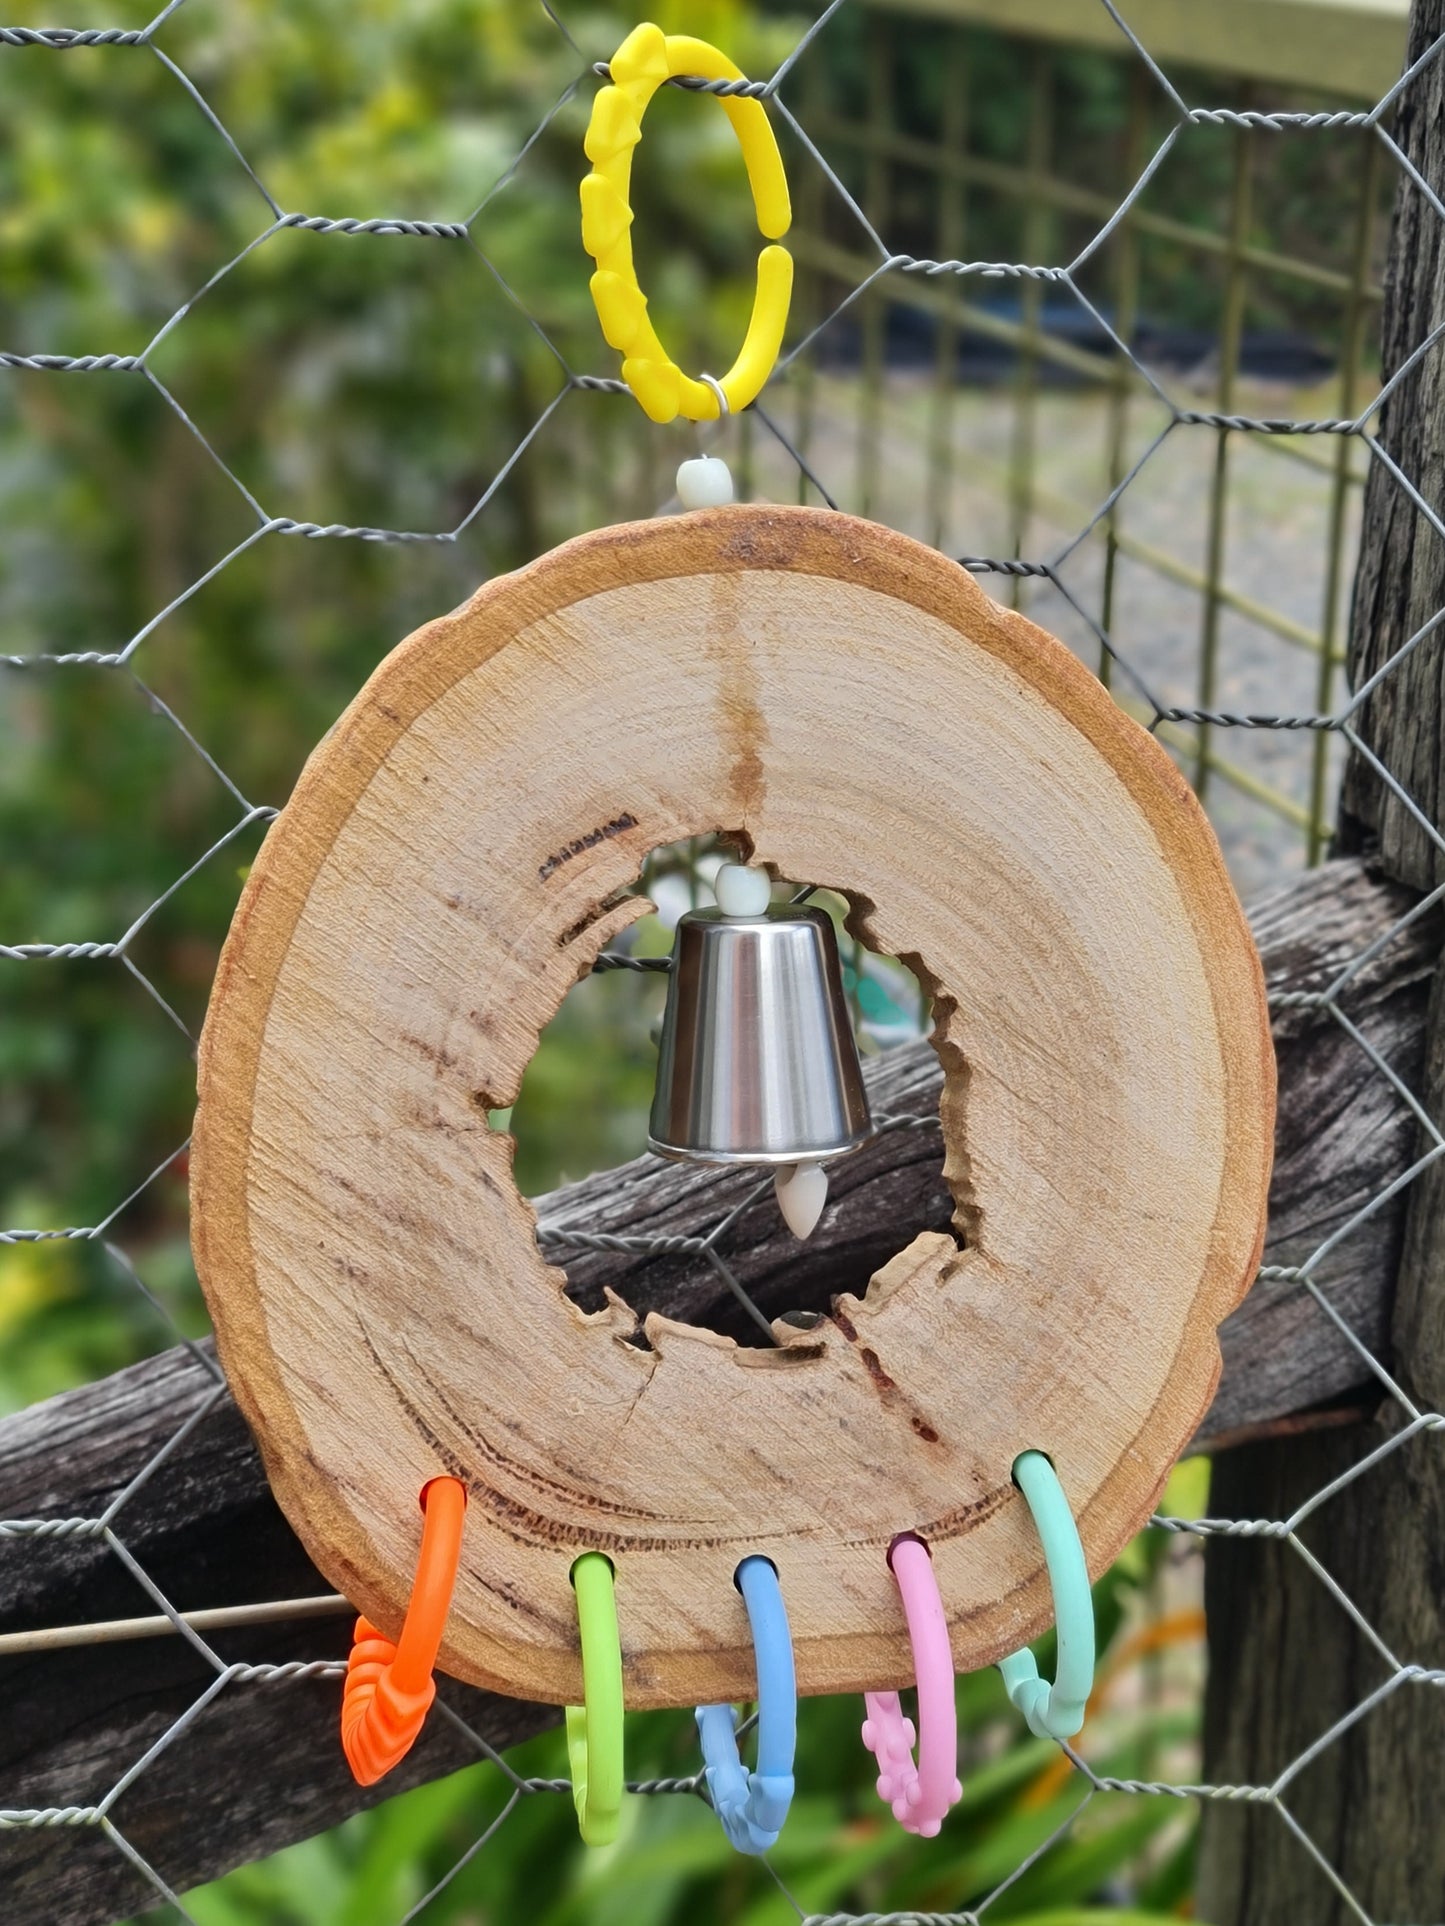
[582,21,792,422]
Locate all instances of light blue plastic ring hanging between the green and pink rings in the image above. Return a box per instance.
[697,1558,798,1853]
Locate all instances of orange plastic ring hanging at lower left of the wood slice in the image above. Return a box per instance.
[341,1477,466,1785]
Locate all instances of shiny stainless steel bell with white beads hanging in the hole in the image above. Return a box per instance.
[647,863,873,1236]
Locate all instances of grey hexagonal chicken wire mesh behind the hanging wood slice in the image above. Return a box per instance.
[0,0,1445,1926]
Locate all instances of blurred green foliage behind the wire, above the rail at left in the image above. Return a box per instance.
[0,0,788,1408]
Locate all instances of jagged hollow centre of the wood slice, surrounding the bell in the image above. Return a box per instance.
[491,838,963,1350]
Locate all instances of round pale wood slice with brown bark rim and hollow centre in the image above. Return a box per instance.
[193,507,1274,1706]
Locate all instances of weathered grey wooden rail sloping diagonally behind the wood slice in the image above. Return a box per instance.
[0,861,1441,1926]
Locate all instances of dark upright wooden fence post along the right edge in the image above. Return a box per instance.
[1198,0,1445,1926]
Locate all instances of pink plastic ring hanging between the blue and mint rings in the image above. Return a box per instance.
[863,1533,963,1839]
